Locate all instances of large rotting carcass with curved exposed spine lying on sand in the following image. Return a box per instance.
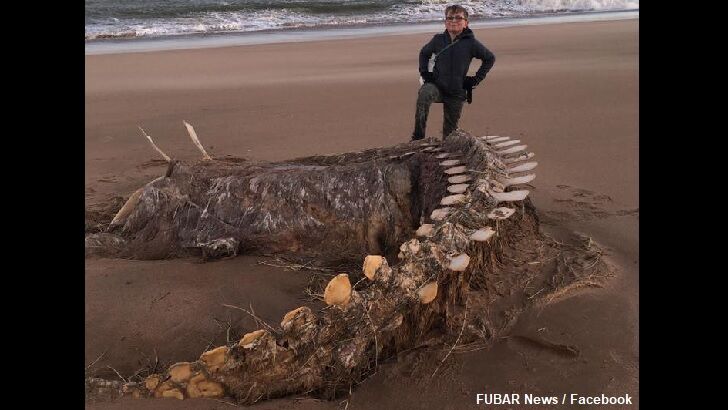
[86,123,560,404]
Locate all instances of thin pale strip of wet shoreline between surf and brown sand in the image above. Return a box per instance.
[84,9,639,56]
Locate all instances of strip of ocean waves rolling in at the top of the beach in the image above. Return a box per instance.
[85,0,639,40]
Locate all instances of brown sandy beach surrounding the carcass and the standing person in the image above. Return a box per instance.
[85,19,639,409]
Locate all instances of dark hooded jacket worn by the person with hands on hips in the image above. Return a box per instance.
[420,28,495,99]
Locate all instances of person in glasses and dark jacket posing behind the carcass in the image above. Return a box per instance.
[412,5,495,140]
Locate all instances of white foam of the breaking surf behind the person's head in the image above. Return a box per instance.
[86,0,639,40]
